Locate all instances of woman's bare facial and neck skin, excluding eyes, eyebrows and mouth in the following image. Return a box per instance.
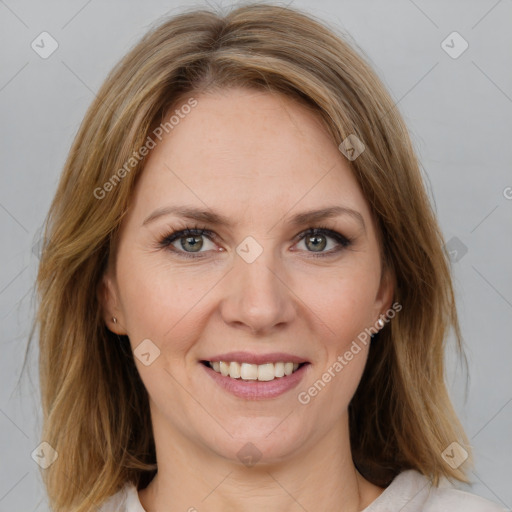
[102,89,393,512]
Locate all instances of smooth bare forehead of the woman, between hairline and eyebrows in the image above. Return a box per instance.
[125,89,370,228]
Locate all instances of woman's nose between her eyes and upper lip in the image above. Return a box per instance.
[220,241,297,335]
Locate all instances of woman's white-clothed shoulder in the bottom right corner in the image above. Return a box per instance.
[363,469,507,512]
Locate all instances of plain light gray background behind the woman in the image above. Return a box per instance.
[0,0,512,512]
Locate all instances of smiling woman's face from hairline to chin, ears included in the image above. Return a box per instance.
[104,89,392,461]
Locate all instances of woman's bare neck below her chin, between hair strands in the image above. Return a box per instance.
[139,408,383,512]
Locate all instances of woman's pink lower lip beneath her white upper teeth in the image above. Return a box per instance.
[199,363,310,400]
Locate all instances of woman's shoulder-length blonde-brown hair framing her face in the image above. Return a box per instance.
[29,4,471,512]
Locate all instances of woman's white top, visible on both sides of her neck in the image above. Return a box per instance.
[99,469,510,512]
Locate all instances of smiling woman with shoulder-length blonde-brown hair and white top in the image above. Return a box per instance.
[33,4,508,512]
